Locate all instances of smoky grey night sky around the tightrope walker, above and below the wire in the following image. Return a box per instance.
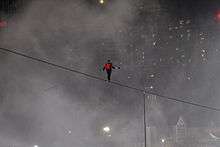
[0,0,220,147]
